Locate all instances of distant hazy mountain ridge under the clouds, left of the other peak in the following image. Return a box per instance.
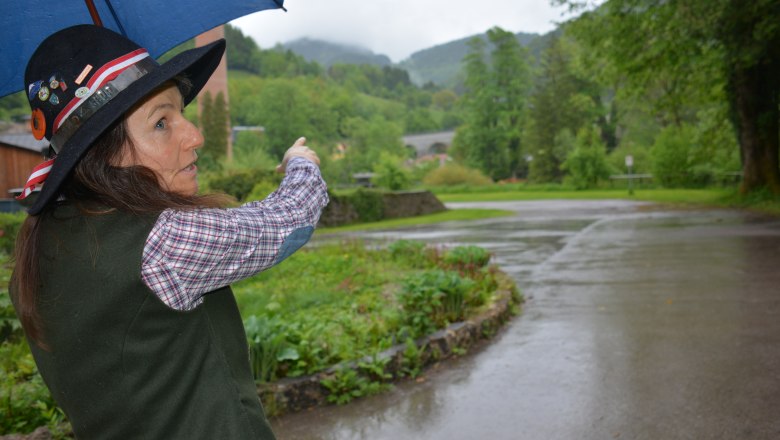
[282,38,393,67]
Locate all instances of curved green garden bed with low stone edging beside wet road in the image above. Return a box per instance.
[235,240,521,415]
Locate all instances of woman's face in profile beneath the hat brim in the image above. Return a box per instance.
[122,85,203,196]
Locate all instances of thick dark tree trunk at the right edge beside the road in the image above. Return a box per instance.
[729,62,780,194]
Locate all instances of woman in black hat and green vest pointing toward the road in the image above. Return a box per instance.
[11,25,327,439]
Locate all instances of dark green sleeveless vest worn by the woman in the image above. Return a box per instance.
[25,206,274,440]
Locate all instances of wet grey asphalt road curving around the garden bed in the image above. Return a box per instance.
[272,201,780,440]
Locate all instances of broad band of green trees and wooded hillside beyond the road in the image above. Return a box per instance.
[0,0,780,196]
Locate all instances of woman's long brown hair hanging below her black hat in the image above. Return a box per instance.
[10,83,232,349]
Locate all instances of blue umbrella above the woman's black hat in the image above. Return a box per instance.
[0,0,284,97]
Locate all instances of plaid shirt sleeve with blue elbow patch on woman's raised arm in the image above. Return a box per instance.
[141,157,328,310]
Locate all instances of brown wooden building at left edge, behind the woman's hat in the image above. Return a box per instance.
[0,133,49,203]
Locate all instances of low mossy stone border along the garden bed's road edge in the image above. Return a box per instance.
[257,290,522,416]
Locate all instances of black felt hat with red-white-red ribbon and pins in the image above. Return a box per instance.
[24,25,225,215]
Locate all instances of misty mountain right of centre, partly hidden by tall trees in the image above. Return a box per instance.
[398,32,540,87]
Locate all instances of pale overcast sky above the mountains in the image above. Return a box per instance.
[232,0,580,62]
